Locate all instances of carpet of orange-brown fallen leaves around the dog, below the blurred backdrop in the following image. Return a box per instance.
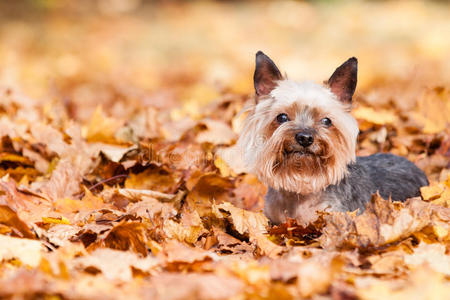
[0,85,450,299]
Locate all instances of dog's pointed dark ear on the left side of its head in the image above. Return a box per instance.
[253,51,283,96]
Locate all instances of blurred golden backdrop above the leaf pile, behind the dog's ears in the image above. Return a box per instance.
[0,0,450,120]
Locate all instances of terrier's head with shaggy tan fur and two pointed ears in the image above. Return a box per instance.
[238,51,358,194]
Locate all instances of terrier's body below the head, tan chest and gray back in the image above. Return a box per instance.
[265,153,428,223]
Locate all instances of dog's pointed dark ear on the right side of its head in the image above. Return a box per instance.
[328,57,358,103]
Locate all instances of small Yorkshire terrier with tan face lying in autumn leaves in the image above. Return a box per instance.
[238,51,428,224]
